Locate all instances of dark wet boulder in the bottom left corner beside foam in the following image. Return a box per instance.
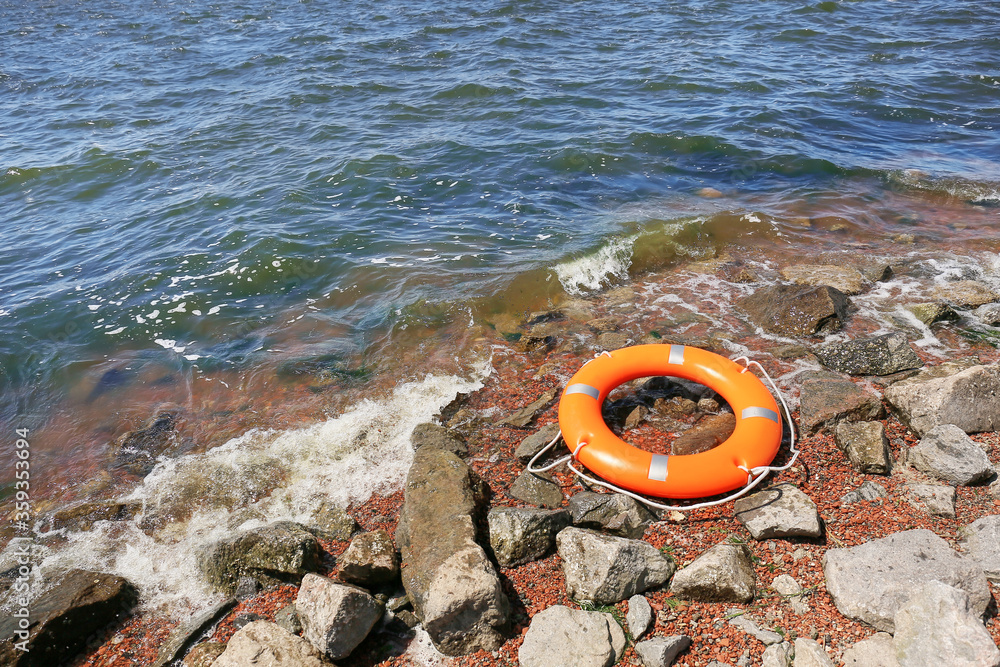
[0,570,138,667]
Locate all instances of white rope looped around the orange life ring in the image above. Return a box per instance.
[527,351,800,511]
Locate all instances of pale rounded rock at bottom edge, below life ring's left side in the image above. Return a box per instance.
[517,605,615,667]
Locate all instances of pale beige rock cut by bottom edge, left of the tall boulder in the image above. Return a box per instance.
[212,621,330,667]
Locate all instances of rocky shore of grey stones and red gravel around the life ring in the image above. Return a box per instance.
[0,260,1000,667]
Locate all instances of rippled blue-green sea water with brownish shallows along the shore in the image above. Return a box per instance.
[0,0,1000,616]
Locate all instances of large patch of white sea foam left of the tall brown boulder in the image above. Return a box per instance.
[6,367,488,615]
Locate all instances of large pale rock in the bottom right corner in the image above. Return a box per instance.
[893,581,1000,667]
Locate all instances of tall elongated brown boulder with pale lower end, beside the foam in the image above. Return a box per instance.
[396,447,510,655]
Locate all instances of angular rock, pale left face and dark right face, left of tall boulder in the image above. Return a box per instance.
[294,574,384,660]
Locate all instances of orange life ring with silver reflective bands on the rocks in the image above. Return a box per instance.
[559,345,782,498]
